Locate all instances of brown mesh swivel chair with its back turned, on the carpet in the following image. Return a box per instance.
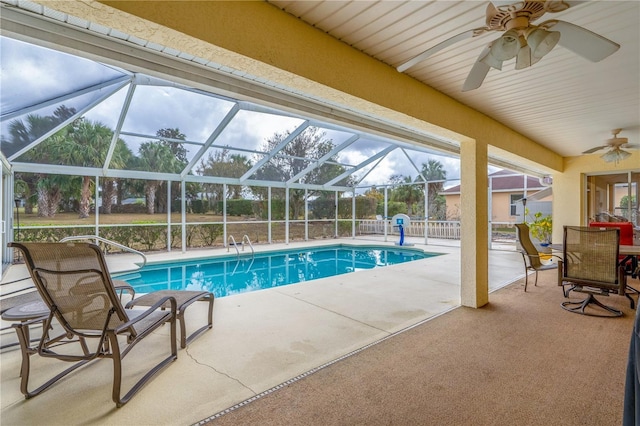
[558,226,635,317]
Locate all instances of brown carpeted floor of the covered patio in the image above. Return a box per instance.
[202,271,638,426]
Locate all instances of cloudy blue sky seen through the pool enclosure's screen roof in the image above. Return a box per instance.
[0,37,470,186]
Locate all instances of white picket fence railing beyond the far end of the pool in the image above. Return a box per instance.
[358,219,460,240]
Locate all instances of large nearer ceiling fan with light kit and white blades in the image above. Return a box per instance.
[397,0,620,92]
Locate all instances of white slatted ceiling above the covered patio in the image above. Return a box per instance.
[268,0,640,156]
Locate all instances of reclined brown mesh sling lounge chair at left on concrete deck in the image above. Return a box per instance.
[9,243,177,407]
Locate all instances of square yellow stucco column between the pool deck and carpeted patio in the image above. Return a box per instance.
[460,141,489,308]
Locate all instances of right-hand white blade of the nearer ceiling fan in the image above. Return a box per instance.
[543,20,620,62]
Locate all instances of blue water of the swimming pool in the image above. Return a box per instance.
[117,245,438,297]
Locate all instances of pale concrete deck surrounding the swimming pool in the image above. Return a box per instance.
[0,238,524,425]
